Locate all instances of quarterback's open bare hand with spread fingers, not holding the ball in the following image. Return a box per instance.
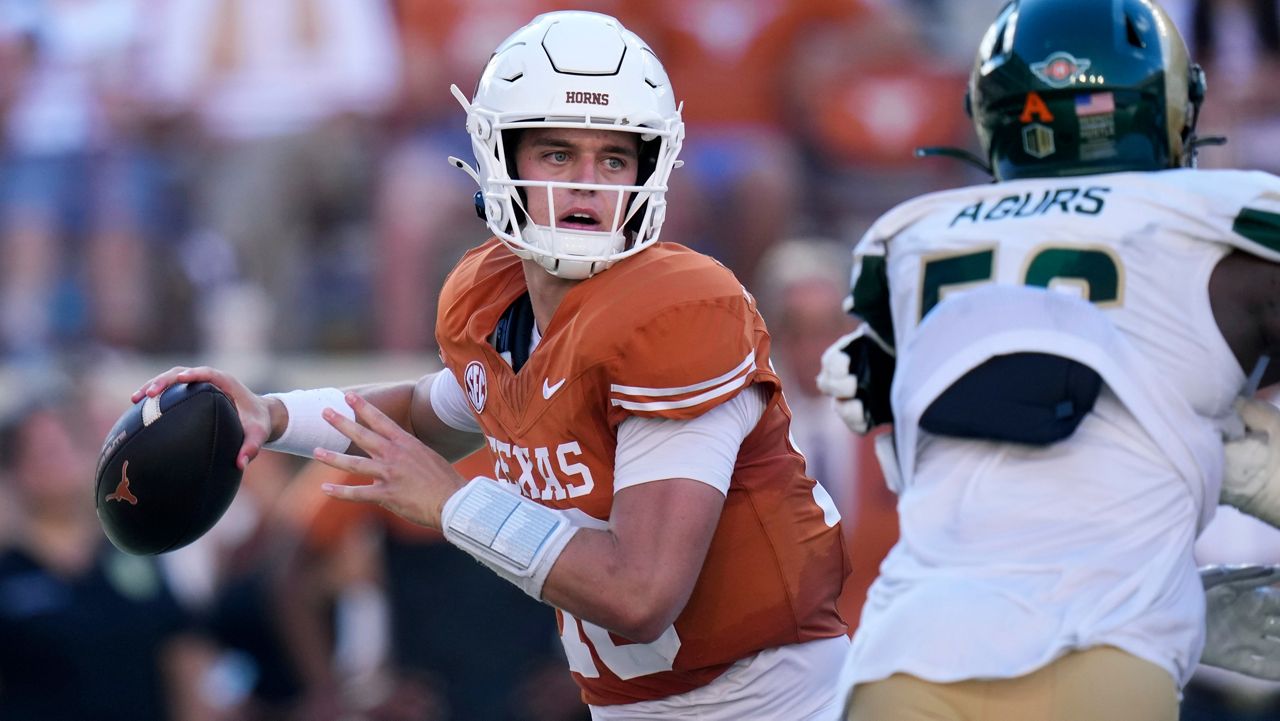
[316,393,466,530]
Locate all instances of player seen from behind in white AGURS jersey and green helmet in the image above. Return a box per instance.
[820,0,1280,721]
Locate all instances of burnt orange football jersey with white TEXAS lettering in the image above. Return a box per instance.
[436,239,849,706]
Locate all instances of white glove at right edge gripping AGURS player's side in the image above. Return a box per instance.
[1221,398,1280,528]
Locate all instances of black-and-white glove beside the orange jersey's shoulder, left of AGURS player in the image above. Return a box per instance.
[817,323,893,435]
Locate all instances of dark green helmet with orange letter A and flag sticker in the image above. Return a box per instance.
[965,0,1204,181]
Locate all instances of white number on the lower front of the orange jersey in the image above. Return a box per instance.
[561,611,680,681]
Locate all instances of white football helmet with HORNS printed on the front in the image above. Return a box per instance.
[449,10,685,279]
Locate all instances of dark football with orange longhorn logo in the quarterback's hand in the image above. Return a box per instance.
[93,383,244,555]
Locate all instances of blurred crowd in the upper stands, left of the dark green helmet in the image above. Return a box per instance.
[0,0,995,361]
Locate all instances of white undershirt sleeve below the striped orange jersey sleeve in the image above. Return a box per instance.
[611,385,765,496]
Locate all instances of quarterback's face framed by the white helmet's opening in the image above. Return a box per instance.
[516,128,640,232]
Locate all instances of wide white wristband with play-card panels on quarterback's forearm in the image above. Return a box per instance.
[440,476,577,601]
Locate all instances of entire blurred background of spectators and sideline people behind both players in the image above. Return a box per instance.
[0,0,1280,721]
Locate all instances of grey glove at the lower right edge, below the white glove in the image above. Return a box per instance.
[1201,565,1280,681]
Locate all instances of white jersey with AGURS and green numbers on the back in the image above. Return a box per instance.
[850,169,1280,684]
